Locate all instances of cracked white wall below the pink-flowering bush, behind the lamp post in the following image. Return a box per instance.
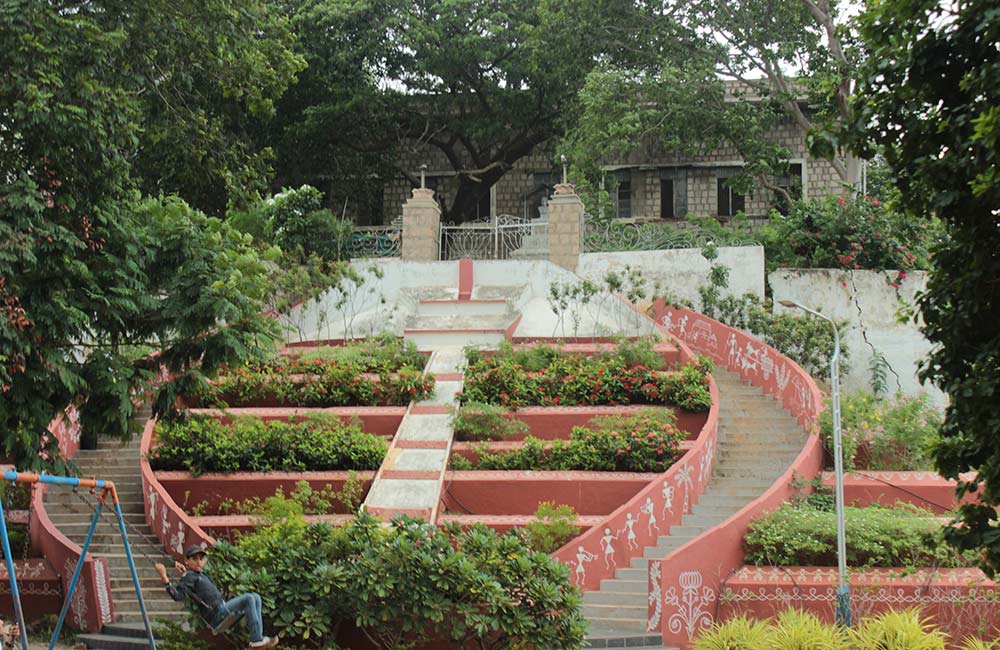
[768,269,946,405]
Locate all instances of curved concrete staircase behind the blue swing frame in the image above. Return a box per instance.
[45,436,188,650]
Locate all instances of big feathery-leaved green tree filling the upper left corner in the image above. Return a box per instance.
[0,0,290,469]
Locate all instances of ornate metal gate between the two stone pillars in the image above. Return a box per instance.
[438,214,549,260]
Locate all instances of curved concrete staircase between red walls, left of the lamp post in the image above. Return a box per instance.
[583,369,807,648]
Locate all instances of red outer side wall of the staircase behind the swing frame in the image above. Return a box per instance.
[25,407,114,631]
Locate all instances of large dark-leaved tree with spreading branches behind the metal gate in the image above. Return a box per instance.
[274,0,660,221]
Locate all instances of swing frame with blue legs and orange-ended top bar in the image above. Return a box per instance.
[0,470,156,650]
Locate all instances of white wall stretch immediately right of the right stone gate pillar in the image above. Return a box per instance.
[576,246,764,309]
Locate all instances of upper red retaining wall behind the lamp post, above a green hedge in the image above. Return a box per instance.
[821,470,978,513]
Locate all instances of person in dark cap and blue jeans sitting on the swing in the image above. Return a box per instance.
[156,544,278,649]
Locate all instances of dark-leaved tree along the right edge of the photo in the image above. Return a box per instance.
[841,0,1000,573]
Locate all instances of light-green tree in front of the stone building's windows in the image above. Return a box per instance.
[565,0,858,201]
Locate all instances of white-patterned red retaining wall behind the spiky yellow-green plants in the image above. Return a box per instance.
[718,566,1000,643]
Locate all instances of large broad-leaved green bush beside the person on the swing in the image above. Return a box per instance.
[209,513,586,649]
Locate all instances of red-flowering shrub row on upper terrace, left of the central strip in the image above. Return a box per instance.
[201,359,434,406]
